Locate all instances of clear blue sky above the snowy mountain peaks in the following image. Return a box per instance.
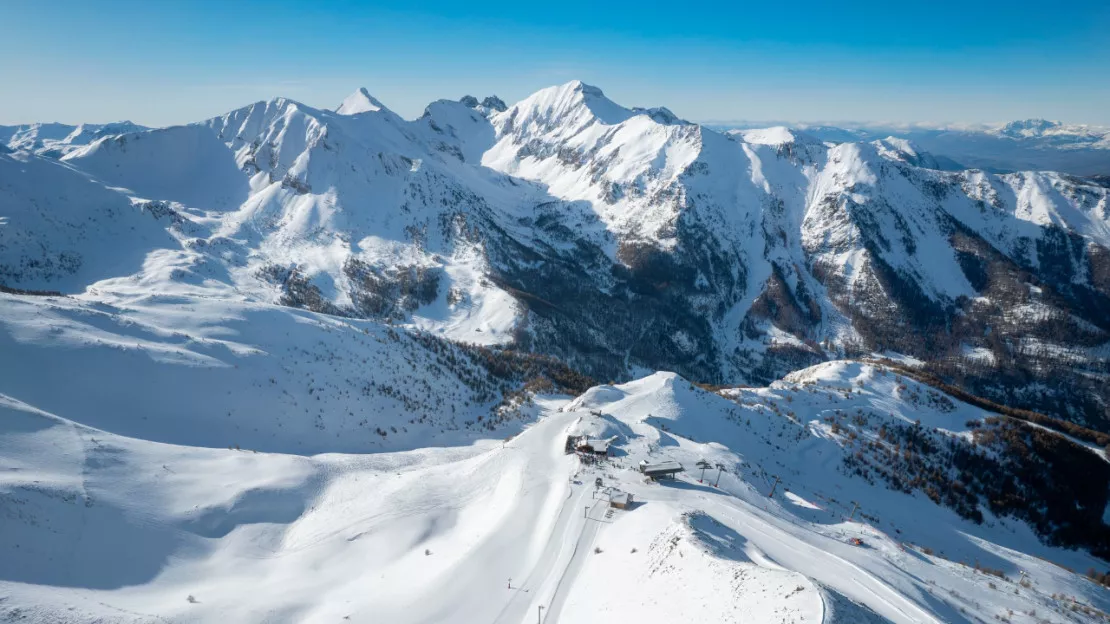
[0,0,1110,125]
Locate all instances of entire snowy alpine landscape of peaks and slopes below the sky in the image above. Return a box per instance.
[0,81,1110,624]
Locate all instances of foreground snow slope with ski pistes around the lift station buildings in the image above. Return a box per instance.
[0,363,1110,624]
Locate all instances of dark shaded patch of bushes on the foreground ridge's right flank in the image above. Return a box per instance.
[844,416,1110,560]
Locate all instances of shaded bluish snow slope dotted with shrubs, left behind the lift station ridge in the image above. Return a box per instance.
[0,292,535,453]
